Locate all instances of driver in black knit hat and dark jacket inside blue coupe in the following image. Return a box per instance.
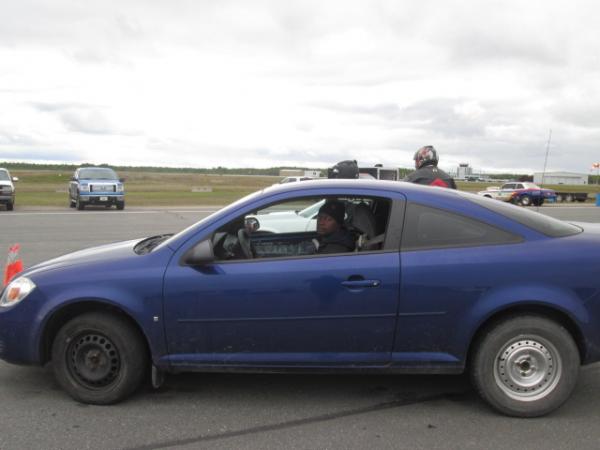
[315,200,355,253]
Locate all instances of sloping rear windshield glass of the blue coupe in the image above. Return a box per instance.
[464,192,583,237]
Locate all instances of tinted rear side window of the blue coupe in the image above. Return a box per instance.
[401,203,522,251]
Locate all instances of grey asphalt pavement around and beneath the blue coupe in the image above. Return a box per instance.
[0,206,600,450]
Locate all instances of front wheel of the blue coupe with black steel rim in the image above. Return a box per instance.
[52,312,150,405]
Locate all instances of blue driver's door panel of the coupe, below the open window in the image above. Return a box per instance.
[164,194,402,367]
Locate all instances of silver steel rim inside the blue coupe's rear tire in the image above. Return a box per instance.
[494,336,562,401]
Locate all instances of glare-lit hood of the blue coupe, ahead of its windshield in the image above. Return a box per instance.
[23,239,141,275]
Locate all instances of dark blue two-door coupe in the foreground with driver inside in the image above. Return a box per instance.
[0,180,600,416]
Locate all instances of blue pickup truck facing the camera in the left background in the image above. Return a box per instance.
[69,167,125,210]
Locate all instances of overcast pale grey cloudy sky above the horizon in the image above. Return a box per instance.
[0,0,600,173]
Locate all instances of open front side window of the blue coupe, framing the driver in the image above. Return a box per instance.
[212,196,397,260]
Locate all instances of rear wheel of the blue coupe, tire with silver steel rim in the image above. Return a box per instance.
[470,315,580,417]
